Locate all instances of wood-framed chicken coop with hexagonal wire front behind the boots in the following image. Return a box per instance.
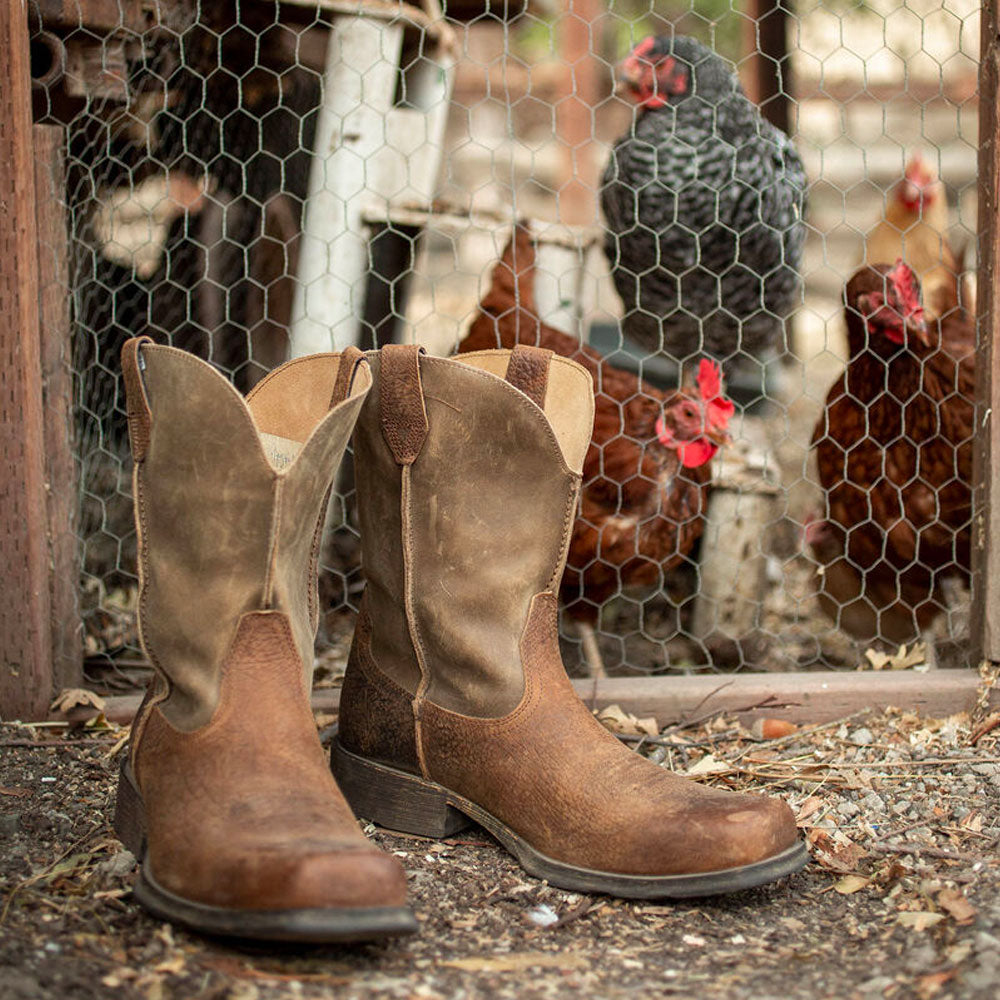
[0,0,1000,718]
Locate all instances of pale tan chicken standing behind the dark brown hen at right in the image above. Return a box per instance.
[861,153,972,319]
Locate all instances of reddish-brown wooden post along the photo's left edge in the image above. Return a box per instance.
[0,0,52,719]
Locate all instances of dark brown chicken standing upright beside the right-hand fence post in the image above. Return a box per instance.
[805,261,975,643]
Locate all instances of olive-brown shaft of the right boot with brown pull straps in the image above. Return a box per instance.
[355,347,593,716]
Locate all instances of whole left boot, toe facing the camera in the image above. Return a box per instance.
[115,338,416,941]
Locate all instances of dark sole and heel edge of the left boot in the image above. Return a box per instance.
[114,761,419,944]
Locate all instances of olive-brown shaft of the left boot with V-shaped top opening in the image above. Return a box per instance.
[123,340,371,731]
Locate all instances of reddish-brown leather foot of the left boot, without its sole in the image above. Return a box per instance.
[135,611,406,910]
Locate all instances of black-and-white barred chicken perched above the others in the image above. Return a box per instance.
[601,37,807,374]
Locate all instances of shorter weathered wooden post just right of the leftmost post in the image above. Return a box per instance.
[33,125,83,692]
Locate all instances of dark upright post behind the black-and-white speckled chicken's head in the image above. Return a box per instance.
[742,0,792,133]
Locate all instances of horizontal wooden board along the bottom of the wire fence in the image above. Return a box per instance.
[105,670,1000,726]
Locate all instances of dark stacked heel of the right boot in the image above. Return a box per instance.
[330,739,471,837]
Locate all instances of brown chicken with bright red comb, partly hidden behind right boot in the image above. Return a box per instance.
[458,223,734,676]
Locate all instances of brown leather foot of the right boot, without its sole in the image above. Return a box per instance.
[421,593,796,875]
